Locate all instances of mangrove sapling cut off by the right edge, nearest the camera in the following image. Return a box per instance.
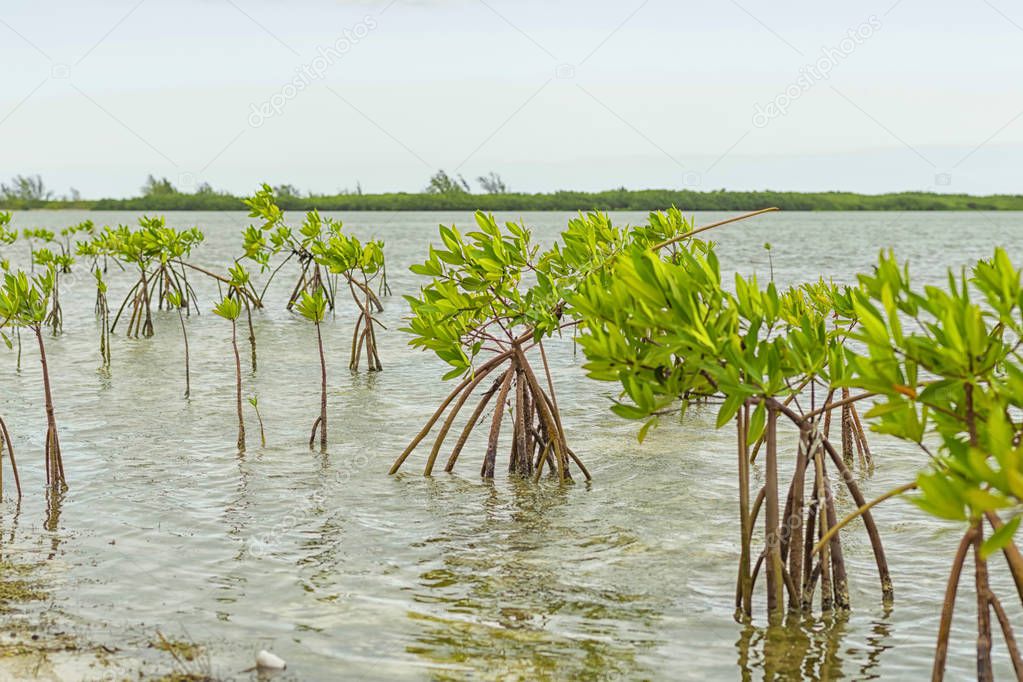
[834,248,1023,680]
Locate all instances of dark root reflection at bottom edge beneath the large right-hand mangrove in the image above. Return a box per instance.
[736,611,891,680]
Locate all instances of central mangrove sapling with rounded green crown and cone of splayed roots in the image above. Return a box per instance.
[391,213,601,482]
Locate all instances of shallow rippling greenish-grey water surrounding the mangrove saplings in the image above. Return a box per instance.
[0,212,1023,680]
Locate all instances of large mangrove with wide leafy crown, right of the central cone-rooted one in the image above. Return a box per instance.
[570,222,893,623]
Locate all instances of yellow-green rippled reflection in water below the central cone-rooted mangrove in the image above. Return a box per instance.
[406,482,659,680]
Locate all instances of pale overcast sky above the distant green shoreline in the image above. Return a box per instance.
[0,0,1023,197]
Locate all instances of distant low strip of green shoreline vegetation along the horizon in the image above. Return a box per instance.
[0,171,1023,212]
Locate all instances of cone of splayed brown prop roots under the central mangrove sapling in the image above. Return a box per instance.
[390,344,590,482]
